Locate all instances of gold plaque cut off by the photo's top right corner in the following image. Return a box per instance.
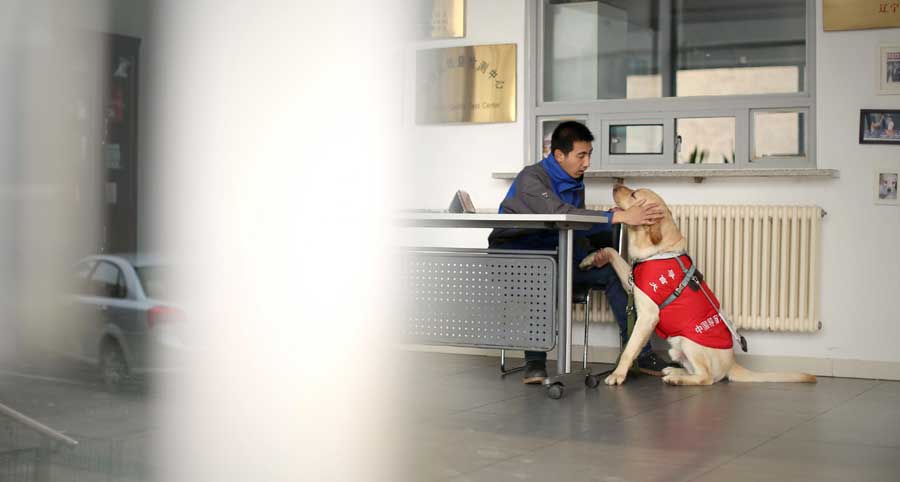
[822,0,900,32]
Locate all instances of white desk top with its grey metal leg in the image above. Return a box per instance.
[395,211,608,383]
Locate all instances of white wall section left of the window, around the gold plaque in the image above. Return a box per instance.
[398,0,525,247]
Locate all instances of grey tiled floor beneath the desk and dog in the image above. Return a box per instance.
[397,353,900,482]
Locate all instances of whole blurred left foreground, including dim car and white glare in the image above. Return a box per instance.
[0,0,400,482]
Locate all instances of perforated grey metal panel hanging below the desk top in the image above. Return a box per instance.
[402,252,557,351]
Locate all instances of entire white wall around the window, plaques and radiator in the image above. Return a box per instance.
[405,0,900,377]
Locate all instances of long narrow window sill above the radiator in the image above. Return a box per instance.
[491,168,840,182]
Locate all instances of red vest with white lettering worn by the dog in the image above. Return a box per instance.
[633,255,732,349]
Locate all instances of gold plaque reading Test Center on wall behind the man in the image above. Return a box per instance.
[416,44,516,124]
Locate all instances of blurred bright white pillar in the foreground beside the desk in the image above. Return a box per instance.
[148,0,403,482]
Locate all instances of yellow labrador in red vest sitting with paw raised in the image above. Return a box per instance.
[593,185,816,385]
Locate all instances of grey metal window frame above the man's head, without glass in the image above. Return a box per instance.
[524,0,816,171]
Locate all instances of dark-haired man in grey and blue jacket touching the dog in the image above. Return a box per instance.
[488,121,666,383]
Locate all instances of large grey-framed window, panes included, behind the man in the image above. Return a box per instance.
[526,0,815,170]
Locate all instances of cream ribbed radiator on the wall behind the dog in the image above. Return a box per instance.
[574,205,824,332]
